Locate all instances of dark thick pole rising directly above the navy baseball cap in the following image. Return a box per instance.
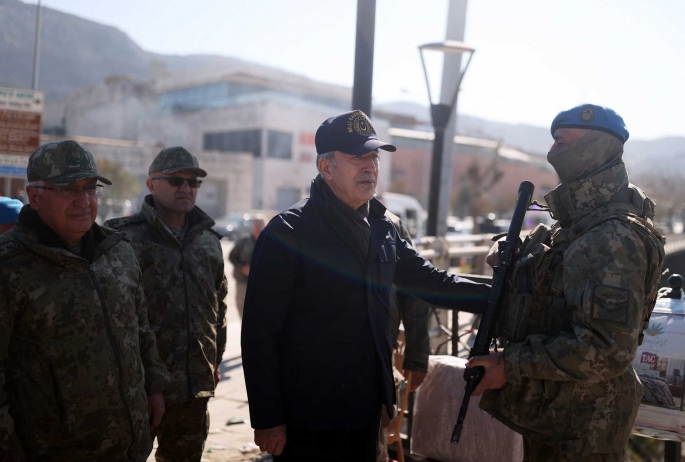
[352,0,376,117]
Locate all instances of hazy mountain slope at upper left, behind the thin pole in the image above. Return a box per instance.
[0,0,272,100]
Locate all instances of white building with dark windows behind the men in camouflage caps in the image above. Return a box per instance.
[46,69,390,218]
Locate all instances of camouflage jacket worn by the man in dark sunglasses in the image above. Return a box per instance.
[105,196,227,402]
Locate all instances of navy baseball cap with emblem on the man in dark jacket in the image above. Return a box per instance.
[315,111,397,156]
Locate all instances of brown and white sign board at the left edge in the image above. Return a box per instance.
[0,87,44,177]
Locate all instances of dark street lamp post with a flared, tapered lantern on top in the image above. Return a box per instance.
[419,40,476,236]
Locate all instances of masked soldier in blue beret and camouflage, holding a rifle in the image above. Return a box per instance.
[468,104,664,462]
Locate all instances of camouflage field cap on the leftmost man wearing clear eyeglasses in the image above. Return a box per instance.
[26,140,112,185]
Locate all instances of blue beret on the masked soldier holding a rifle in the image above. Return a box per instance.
[552,104,630,143]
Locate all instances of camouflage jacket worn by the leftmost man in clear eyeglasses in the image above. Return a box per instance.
[0,206,169,461]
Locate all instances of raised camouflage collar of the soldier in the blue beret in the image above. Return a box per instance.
[545,162,629,225]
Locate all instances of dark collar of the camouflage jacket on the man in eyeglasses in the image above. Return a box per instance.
[12,205,124,262]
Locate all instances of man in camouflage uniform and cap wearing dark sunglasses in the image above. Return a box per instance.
[105,147,227,461]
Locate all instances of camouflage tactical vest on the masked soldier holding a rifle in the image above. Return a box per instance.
[498,187,664,345]
